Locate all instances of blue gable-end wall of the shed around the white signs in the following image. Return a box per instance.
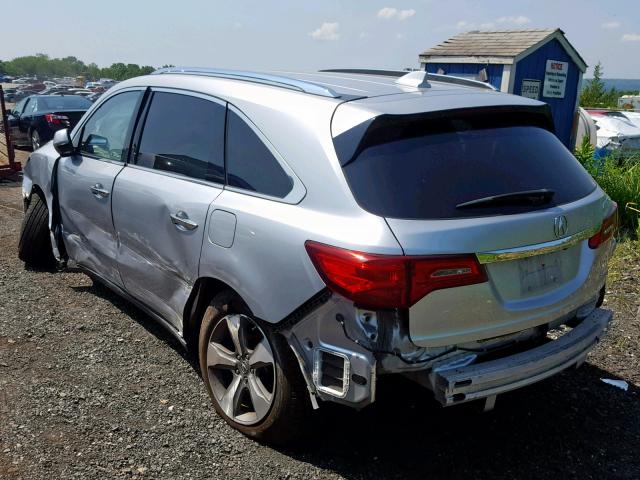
[513,40,580,148]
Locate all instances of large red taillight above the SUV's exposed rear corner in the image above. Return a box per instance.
[305,241,487,308]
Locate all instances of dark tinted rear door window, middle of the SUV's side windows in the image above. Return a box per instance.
[136,92,226,183]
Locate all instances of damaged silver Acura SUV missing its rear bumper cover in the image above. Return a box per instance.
[20,68,616,442]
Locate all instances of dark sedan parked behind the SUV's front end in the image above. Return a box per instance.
[8,95,92,150]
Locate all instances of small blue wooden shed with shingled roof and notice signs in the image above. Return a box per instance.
[420,28,587,148]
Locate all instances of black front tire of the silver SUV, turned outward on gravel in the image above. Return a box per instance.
[18,192,55,268]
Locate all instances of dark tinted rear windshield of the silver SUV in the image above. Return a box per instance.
[334,111,596,219]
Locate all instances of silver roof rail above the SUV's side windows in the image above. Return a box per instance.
[152,67,340,98]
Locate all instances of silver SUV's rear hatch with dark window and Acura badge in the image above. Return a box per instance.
[334,94,612,346]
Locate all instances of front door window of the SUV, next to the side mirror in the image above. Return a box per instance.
[80,92,142,162]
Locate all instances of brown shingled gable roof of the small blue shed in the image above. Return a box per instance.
[420,28,587,72]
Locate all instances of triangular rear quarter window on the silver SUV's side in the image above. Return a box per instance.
[227,110,293,198]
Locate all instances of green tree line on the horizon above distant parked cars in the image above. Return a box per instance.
[0,53,168,80]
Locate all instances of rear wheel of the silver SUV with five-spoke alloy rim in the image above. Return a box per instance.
[198,291,311,445]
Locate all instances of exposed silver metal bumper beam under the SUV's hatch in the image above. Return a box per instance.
[430,308,613,406]
